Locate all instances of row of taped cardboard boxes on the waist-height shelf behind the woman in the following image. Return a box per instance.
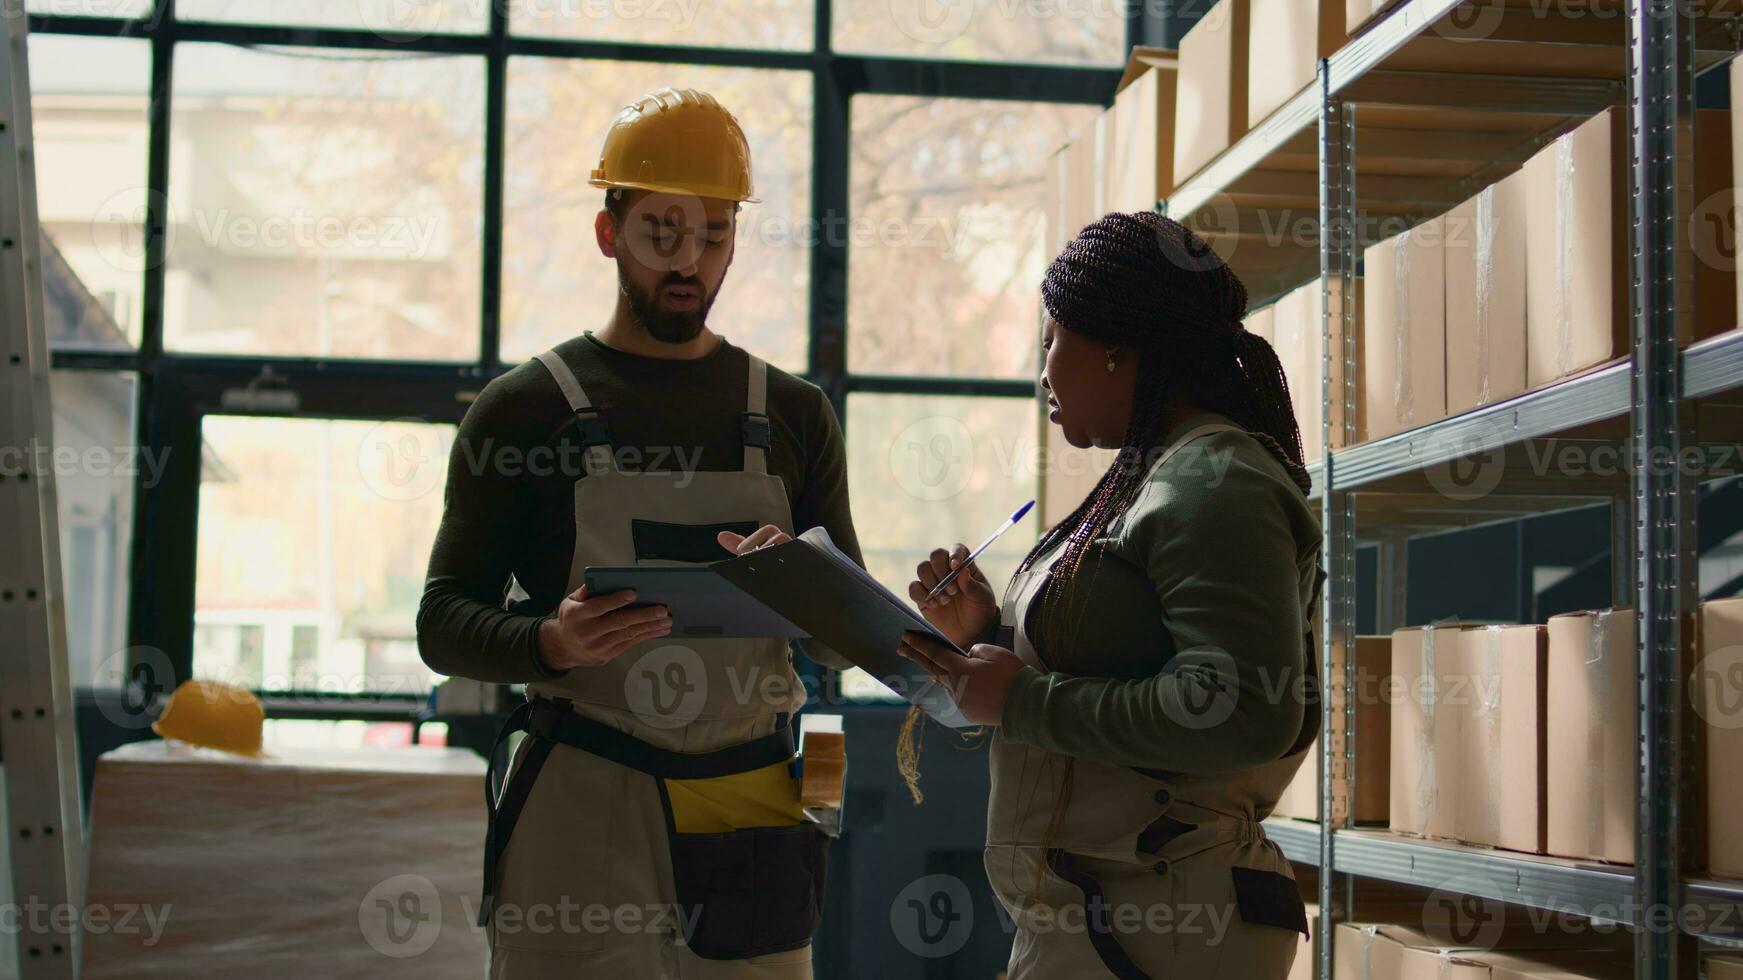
[1380,598,1743,877]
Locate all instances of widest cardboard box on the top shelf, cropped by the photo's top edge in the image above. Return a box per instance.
[1246,0,1347,129]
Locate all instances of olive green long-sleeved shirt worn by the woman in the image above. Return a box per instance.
[1000,415,1319,772]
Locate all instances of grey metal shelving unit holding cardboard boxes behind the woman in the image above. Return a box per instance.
[1161,0,1743,980]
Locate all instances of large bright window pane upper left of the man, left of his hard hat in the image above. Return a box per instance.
[164,44,485,361]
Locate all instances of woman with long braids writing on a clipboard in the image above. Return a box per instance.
[901,213,1319,980]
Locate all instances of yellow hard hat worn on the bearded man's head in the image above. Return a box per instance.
[587,89,756,204]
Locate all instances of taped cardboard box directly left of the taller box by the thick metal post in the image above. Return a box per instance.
[1447,626,1550,854]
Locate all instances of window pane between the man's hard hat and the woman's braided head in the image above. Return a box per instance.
[847,96,1096,378]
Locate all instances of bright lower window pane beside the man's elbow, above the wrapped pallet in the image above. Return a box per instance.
[193,415,453,694]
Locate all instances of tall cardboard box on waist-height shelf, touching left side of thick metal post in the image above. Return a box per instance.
[1546,609,1640,863]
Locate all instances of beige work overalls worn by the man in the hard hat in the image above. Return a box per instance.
[481,352,826,980]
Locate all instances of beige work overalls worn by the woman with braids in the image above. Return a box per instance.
[985,424,1318,980]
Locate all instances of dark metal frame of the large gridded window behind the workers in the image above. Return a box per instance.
[28,0,1129,720]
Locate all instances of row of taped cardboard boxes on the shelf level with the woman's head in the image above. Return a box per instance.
[1361,108,1738,439]
